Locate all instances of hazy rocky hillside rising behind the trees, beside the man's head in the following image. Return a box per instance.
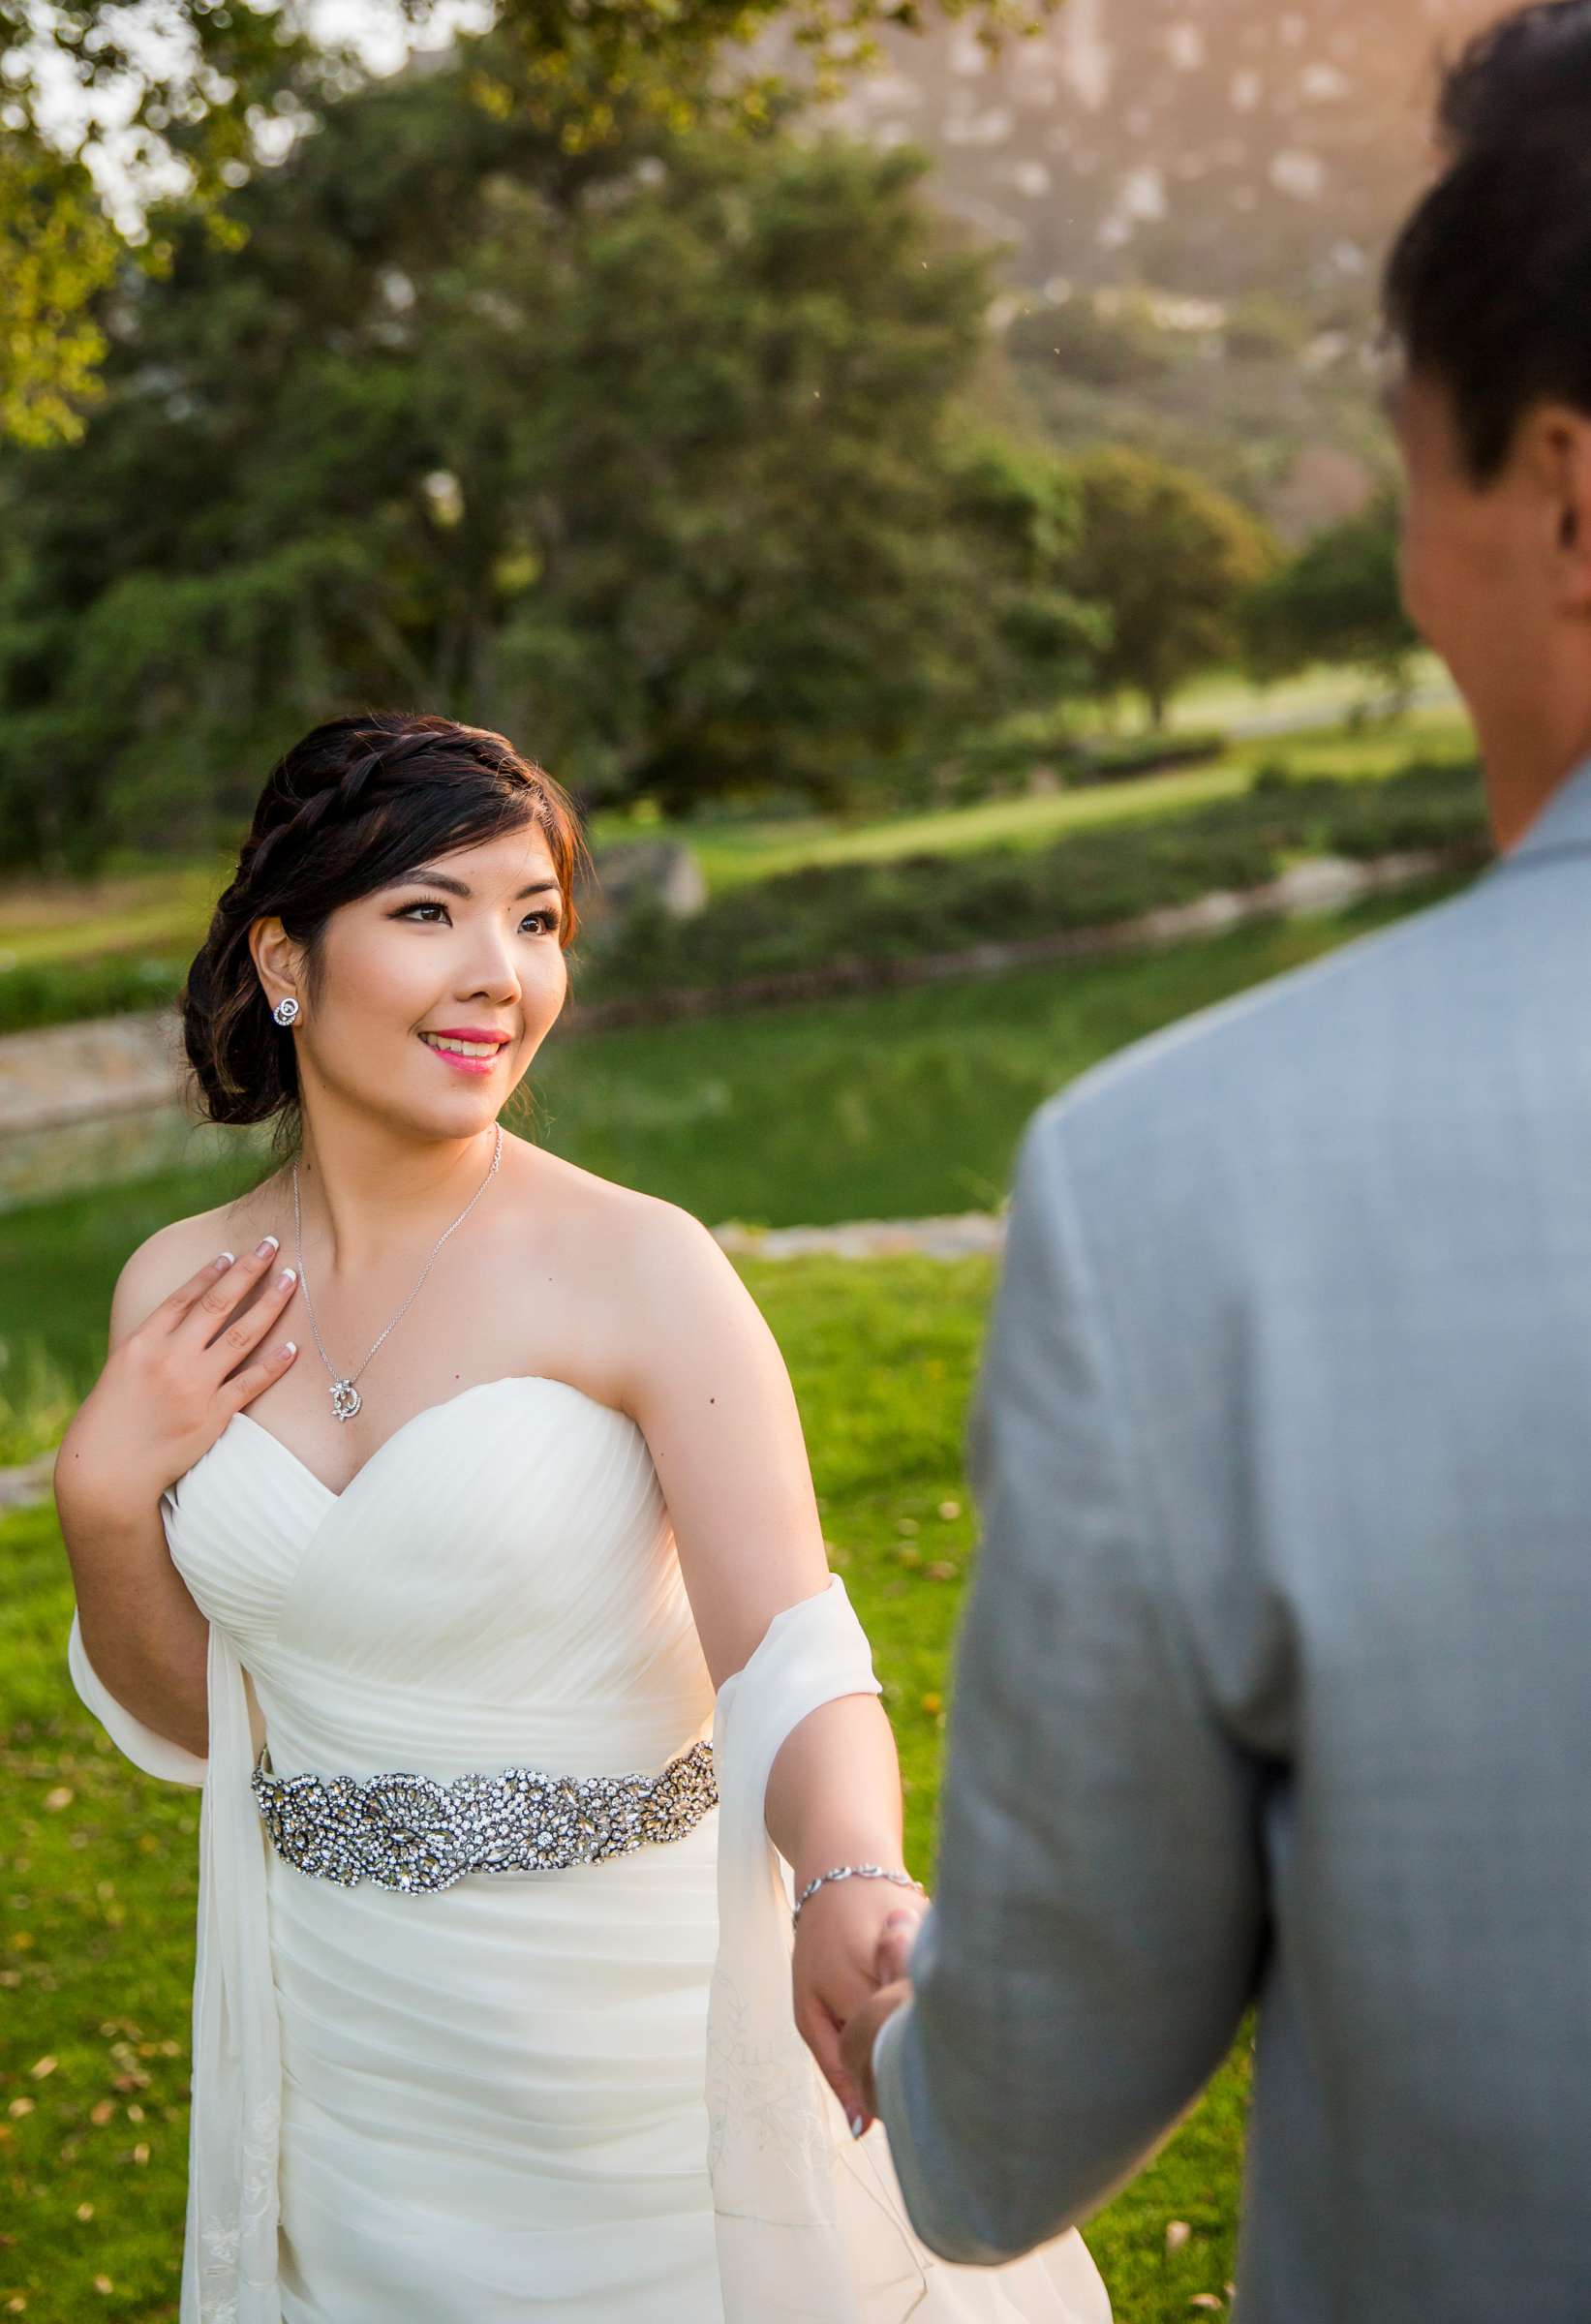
[784,0,1496,539]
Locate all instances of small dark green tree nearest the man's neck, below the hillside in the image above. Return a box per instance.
[1240,493,1420,707]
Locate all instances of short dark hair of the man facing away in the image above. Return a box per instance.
[1382,0,1591,483]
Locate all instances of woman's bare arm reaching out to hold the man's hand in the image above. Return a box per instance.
[620,1202,910,2115]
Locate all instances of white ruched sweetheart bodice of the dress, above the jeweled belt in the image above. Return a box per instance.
[165,1373,713,1780]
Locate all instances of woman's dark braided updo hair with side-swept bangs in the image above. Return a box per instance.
[181,711,590,1162]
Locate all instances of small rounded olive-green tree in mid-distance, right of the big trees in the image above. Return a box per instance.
[1073,446,1275,727]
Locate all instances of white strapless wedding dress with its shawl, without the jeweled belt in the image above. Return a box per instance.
[68,1376,1111,2324]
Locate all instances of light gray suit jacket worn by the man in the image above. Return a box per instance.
[875,767,1591,2324]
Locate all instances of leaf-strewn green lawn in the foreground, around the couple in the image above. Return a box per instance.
[0,1260,1247,2324]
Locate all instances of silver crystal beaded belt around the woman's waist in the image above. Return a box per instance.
[249,1743,718,1889]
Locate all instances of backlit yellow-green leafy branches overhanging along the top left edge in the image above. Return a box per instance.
[0,0,1059,443]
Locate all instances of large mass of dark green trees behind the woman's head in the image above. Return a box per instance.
[0,54,1089,873]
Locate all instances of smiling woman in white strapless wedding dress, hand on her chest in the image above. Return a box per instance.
[56,714,1111,2324]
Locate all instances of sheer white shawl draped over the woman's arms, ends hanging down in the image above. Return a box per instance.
[68,1574,936,2324]
